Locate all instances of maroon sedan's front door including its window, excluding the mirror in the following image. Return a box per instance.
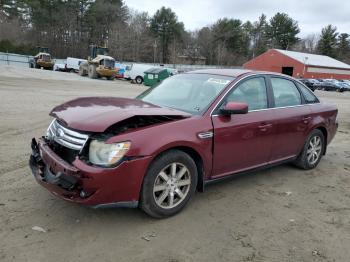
[212,76,274,178]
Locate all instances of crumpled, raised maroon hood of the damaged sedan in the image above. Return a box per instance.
[50,97,191,132]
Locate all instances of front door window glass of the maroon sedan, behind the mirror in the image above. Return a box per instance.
[226,77,267,111]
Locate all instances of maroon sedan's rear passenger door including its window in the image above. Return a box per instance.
[270,76,312,162]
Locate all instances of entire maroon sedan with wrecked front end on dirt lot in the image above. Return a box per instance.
[30,70,337,217]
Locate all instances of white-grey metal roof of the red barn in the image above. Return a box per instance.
[275,49,350,69]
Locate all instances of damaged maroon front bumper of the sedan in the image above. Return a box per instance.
[29,138,151,207]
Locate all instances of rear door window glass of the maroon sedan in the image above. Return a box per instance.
[271,77,301,107]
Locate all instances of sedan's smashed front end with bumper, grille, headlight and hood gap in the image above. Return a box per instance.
[29,107,190,207]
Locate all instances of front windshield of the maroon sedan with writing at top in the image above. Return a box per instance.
[137,74,234,114]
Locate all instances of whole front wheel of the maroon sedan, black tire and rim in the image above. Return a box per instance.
[140,150,198,218]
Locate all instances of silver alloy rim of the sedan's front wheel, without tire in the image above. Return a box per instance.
[153,163,192,209]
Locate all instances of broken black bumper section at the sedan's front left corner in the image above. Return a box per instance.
[29,138,78,191]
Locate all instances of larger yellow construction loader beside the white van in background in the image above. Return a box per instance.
[79,45,118,80]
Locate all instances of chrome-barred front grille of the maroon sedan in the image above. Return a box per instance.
[48,119,89,151]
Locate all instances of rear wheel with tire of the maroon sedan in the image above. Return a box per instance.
[294,129,325,170]
